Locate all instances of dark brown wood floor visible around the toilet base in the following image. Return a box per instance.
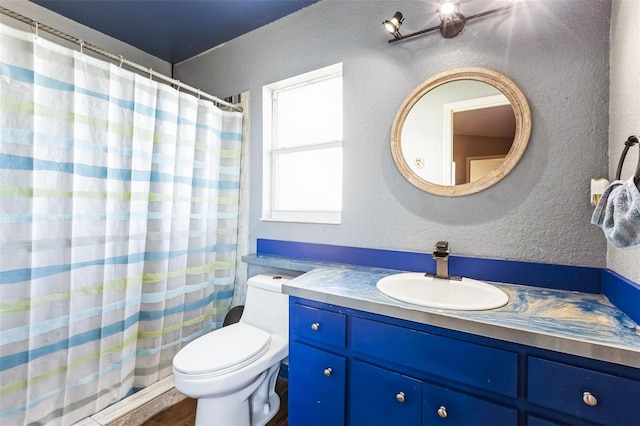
[141,378,288,426]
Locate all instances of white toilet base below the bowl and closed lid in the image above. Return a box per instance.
[195,363,280,426]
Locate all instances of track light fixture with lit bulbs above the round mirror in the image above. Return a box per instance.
[382,0,514,43]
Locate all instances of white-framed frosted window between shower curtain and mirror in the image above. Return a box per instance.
[262,64,342,223]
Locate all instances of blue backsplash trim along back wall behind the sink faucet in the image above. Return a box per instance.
[257,239,600,294]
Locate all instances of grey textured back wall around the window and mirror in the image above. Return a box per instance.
[176,0,611,274]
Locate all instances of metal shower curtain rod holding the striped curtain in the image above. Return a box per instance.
[0,6,242,112]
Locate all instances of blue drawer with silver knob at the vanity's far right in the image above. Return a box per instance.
[527,357,640,426]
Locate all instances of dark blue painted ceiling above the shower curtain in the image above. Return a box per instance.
[30,0,319,64]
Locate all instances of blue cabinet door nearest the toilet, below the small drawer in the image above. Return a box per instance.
[288,341,347,426]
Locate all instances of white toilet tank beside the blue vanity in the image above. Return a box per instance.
[240,274,293,334]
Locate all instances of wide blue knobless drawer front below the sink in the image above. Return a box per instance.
[351,317,518,397]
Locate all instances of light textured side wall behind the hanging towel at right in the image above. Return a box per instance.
[607,0,640,283]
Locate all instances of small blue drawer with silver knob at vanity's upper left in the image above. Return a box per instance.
[289,303,347,348]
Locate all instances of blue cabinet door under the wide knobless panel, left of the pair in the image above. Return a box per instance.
[349,361,422,426]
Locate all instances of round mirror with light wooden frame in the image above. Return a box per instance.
[391,67,531,196]
